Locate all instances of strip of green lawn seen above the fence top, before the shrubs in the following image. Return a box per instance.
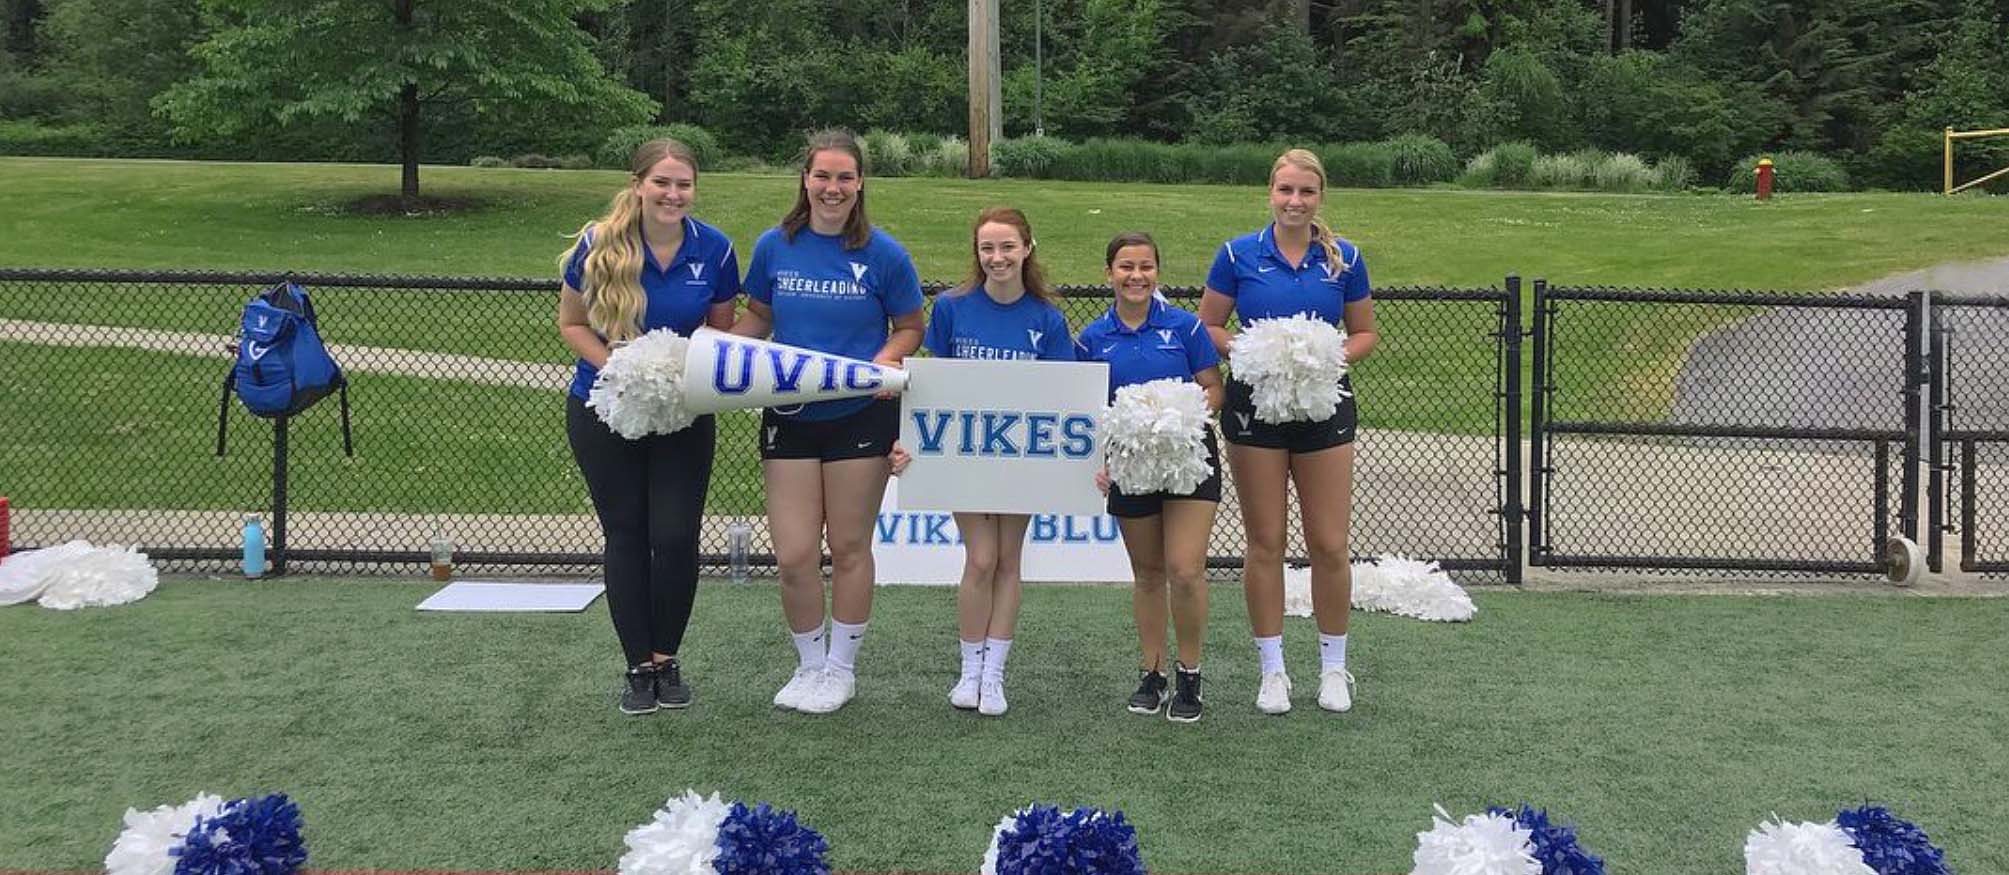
[11,159,2009,289]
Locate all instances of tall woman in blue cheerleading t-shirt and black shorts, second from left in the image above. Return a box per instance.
[733,130,924,714]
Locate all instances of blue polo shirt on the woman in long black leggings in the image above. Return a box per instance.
[565,217,739,401]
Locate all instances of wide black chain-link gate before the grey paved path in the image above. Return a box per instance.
[1527,281,1925,574]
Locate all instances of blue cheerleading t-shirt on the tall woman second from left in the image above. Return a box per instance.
[745,227,924,419]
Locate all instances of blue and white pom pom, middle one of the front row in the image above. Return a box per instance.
[982,805,1145,875]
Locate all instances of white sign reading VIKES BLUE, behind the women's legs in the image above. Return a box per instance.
[872,478,1131,586]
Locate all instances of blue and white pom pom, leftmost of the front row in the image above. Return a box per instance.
[104,793,307,875]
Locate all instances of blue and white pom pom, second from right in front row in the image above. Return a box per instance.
[1410,805,1605,875]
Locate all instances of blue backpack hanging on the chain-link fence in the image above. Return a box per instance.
[217,281,356,456]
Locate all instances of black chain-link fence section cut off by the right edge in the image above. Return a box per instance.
[1927,293,2009,572]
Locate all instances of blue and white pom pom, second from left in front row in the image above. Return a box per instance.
[619,791,830,875]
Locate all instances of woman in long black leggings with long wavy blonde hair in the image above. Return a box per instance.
[559,140,739,714]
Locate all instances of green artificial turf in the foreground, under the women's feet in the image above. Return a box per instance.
[0,580,2009,875]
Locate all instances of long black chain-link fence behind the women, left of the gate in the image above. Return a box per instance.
[0,269,1519,580]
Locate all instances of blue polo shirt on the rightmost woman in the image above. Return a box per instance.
[1207,225,1368,325]
